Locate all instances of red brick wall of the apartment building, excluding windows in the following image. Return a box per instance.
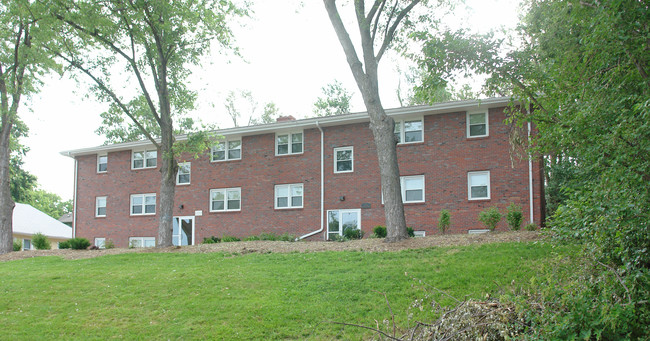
[76,108,542,247]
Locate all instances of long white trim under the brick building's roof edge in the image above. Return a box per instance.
[60,97,512,158]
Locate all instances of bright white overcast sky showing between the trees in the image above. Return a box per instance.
[20,0,520,200]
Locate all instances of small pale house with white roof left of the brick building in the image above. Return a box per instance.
[13,203,72,250]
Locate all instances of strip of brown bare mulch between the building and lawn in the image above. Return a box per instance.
[0,231,542,262]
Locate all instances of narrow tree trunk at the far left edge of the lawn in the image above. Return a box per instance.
[0,118,16,254]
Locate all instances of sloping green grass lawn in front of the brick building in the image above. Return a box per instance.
[0,242,575,340]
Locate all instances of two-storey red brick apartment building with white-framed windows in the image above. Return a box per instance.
[62,98,543,247]
